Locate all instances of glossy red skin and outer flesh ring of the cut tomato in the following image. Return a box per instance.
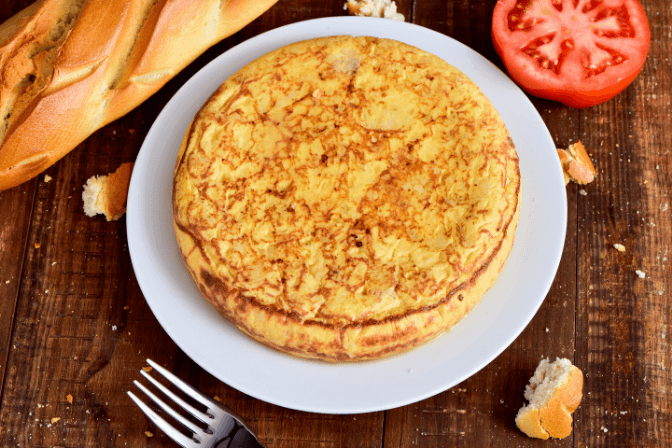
[492,0,651,109]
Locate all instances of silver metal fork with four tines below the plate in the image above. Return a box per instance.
[127,359,264,448]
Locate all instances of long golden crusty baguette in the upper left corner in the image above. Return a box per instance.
[0,0,277,191]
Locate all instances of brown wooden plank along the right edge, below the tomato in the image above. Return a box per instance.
[575,2,672,447]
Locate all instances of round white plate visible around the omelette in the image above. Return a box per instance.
[127,17,567,414]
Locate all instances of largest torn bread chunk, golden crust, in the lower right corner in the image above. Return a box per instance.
[516,358,583,440]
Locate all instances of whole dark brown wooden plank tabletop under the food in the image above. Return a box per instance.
[0,0,672,448]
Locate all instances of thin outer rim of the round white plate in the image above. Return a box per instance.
[127,17,567,414]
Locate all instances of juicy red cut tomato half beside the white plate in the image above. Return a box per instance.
[492,0,651,108]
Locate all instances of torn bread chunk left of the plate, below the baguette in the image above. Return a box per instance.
[82,162,133,221]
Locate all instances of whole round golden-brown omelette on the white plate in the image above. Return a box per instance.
[173,36,520,360]
